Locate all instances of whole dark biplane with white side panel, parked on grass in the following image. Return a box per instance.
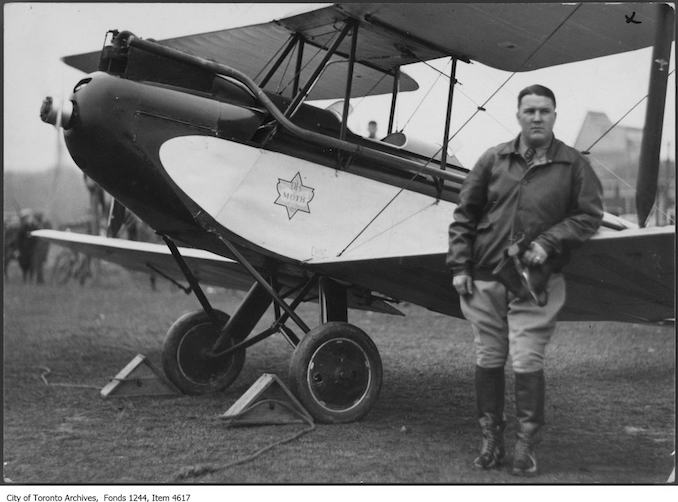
[36,3,675,422]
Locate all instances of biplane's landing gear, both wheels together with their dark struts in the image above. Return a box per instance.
[158,236,382,423]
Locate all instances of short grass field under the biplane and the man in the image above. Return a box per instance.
[3,269,675,484]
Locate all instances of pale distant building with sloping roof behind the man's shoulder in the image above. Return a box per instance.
[574,111,676,225]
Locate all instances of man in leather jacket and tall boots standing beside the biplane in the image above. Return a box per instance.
[447,85,603,475]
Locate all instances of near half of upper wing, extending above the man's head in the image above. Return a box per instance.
[322,2,668,71]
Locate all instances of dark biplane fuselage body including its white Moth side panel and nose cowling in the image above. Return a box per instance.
[65,68,468,314]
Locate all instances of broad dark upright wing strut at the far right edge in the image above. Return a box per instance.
[636,4,674,227]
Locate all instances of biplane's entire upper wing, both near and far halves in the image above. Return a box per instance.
[63,3,668,100]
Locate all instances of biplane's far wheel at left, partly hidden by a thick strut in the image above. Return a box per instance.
[162,310,245,395]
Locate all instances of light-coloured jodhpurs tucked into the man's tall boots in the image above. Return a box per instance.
[460,274,565,373]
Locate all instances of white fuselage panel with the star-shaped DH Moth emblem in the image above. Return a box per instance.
[160,136,455,263]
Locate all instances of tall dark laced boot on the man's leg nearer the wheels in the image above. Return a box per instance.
[473,366,506,469]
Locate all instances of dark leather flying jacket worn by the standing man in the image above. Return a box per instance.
[446,136,603,280]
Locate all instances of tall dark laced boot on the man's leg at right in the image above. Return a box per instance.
[513,370,545,476]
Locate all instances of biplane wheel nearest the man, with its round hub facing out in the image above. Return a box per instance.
[289,322,382,423]
